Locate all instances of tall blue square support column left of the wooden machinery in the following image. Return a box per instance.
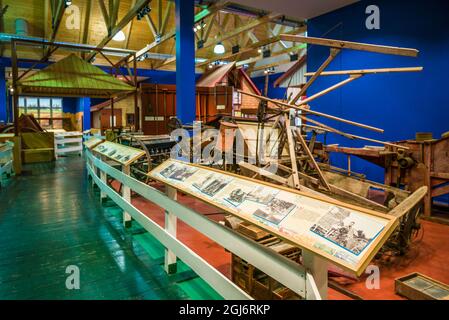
[175,0,196,124]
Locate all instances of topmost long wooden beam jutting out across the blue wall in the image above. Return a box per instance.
[281,34,419,57]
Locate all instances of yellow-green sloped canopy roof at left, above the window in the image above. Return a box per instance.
[18,54,135,98]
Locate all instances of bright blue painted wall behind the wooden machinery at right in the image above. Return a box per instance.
[308,0,449,181]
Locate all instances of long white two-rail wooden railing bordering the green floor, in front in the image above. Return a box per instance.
[85,150,318,299]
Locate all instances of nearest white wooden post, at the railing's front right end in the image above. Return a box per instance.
[302,249,328,300]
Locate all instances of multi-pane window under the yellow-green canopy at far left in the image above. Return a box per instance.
[19,97,63,129]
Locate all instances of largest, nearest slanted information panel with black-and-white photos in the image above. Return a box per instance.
[149,159,397,275]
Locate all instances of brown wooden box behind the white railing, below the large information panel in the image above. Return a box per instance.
[227,218,301,300]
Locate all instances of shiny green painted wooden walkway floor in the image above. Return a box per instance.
[0,158,221,299]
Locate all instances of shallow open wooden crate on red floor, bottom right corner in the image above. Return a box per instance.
[395,272,449,300]
